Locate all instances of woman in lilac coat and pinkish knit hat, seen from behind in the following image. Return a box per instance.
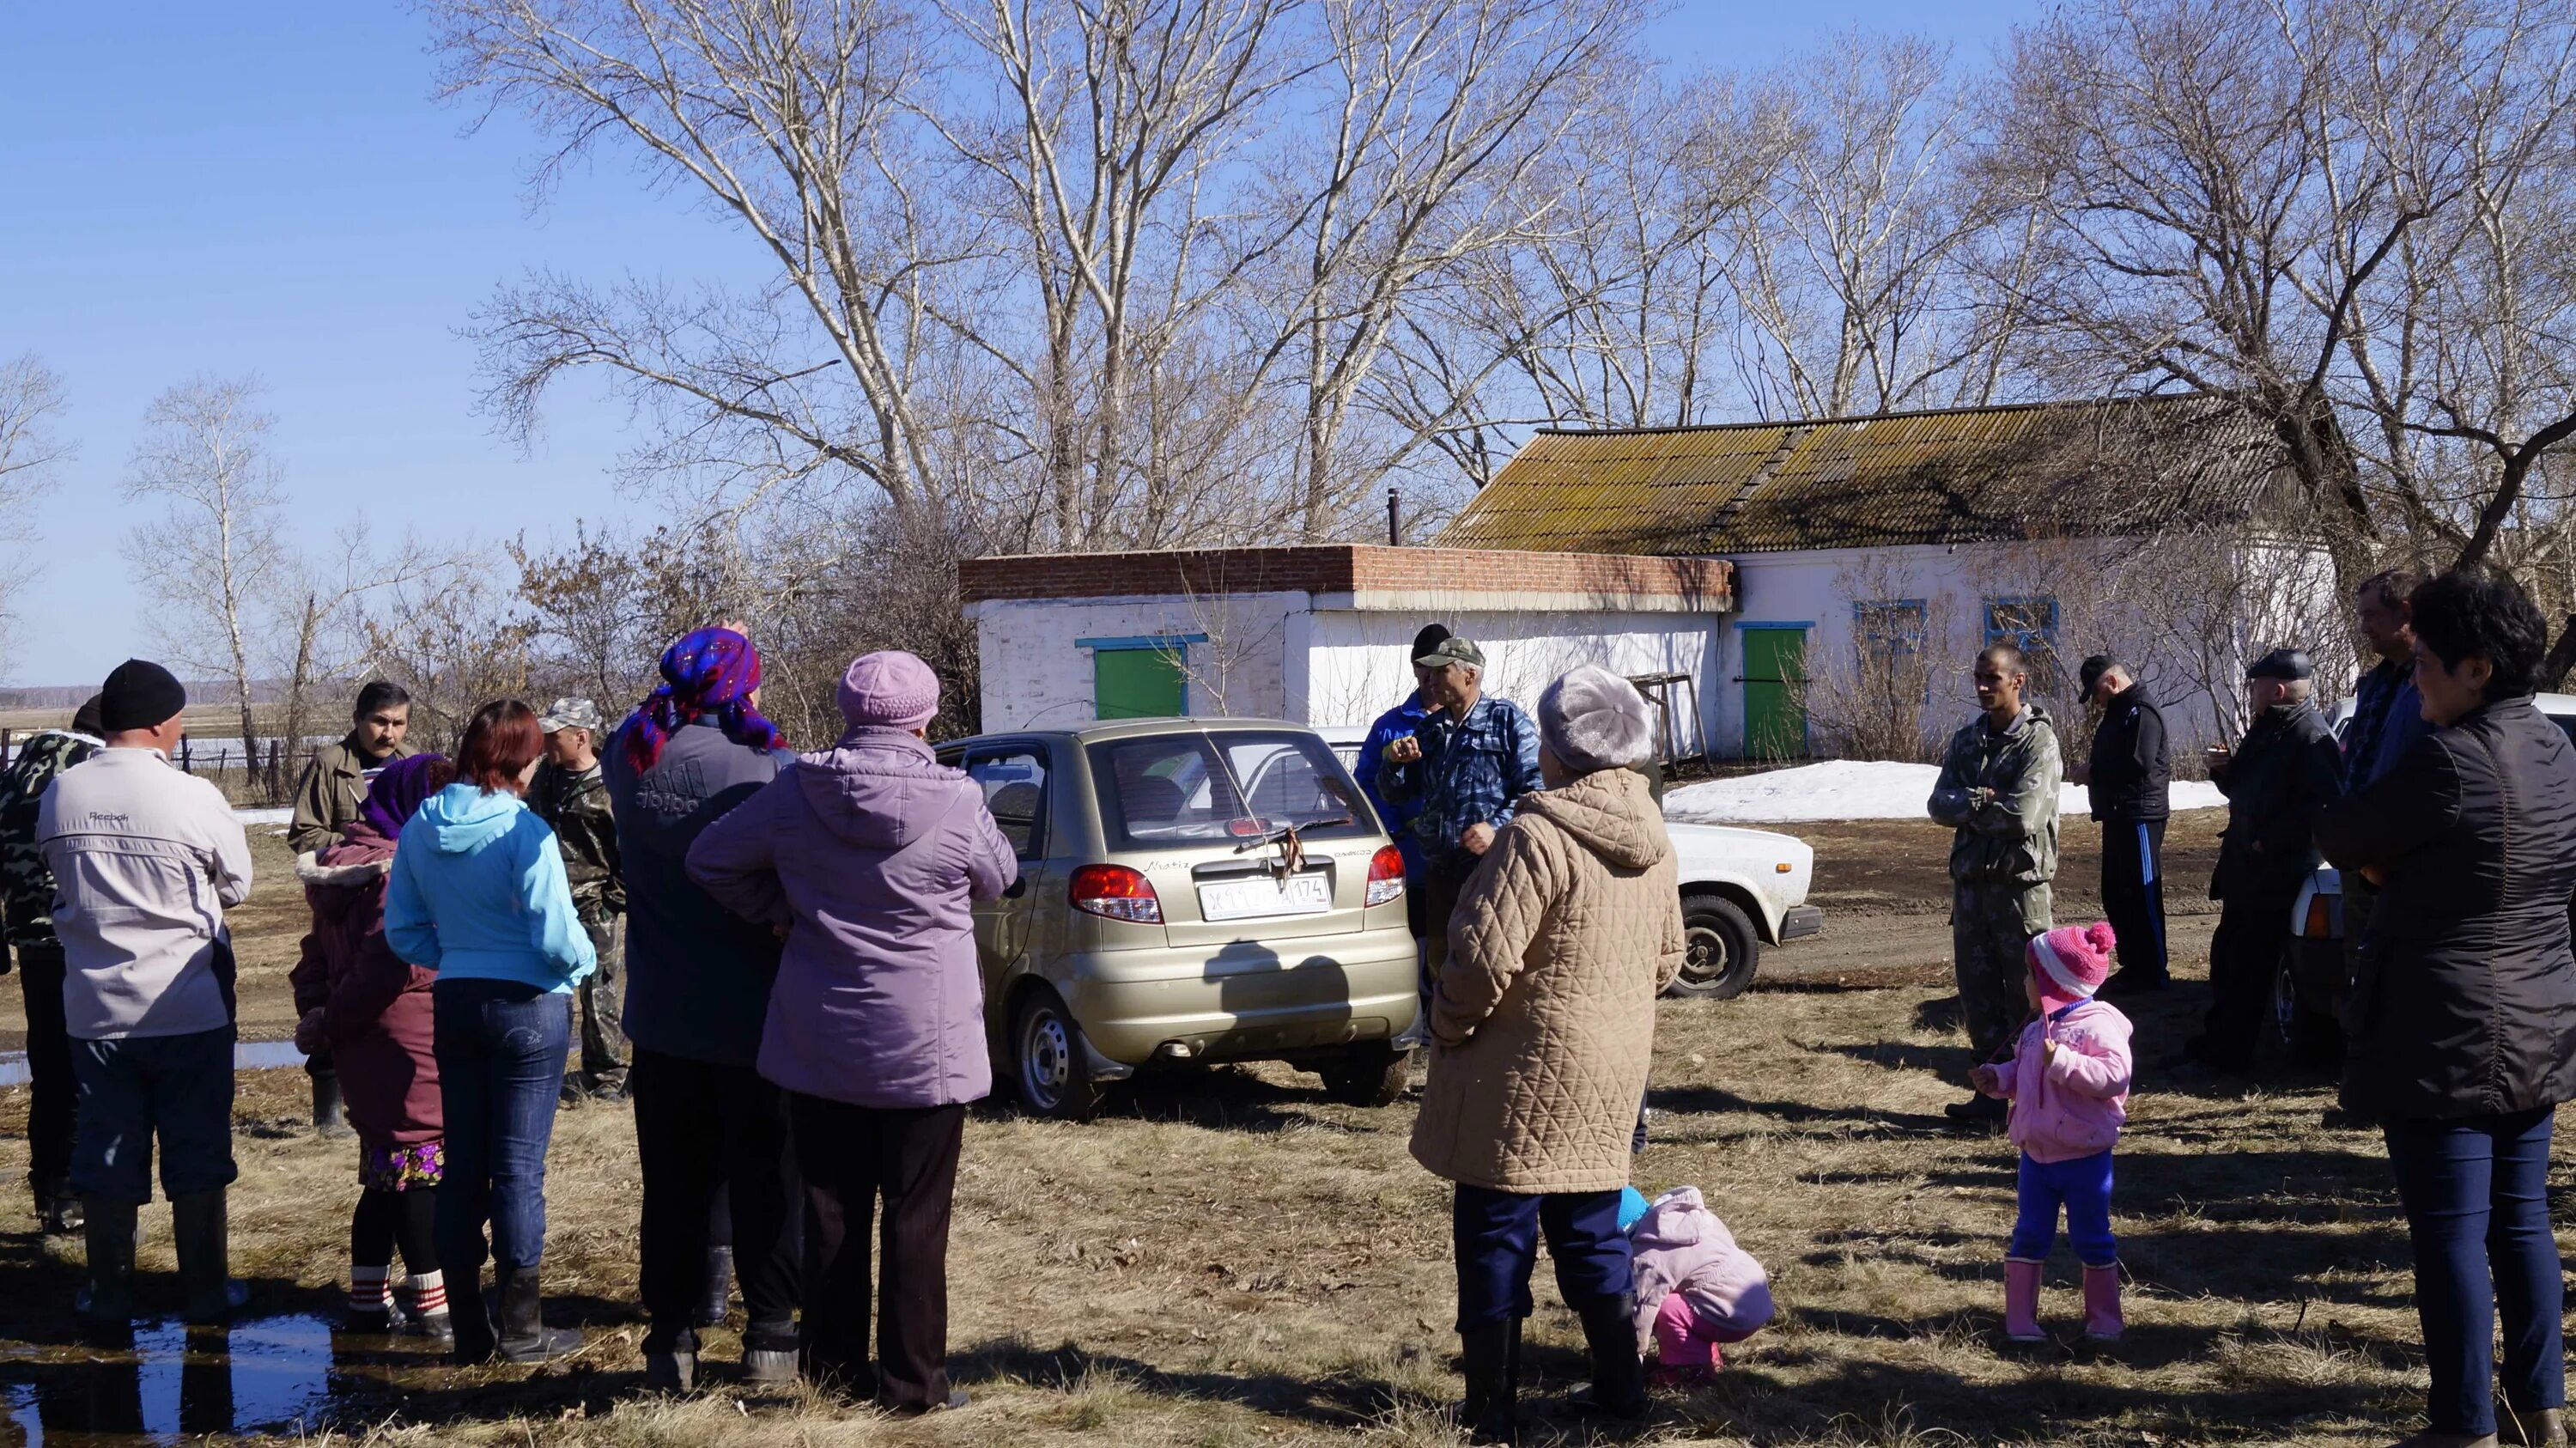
[688,652,1020,1415]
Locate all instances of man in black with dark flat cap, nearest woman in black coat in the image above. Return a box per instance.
[2182,649,2344,1074]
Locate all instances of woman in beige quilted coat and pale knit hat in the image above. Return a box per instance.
[1414,667,1682,1443]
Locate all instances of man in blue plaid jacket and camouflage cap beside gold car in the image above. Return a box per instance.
[1378,639,1543,979]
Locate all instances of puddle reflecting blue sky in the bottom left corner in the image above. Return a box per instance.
[0,1314,438,1448]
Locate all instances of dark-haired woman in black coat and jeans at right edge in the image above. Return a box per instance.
[2316,572,2576,1448]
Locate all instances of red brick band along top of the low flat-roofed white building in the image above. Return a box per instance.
[958,544,1731,603]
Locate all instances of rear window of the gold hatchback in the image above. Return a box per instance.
[1090,729,1376,848]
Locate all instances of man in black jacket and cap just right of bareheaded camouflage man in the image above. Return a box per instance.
[2076,654,2174,995]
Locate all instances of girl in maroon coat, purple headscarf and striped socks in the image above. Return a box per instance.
[291,755,456,1337]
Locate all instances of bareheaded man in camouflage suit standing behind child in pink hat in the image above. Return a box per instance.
[1929,644,2066,1121]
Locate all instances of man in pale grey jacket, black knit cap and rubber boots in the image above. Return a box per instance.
[36,660,250,1324]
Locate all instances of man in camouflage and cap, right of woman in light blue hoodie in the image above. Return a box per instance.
[528,698,629,1100]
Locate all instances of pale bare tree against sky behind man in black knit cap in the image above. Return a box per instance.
[126,376,286,768]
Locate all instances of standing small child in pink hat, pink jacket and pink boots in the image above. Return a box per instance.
[1968,925,2130,1342]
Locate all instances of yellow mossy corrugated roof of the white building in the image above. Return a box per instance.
[1437,397,2280,554]
